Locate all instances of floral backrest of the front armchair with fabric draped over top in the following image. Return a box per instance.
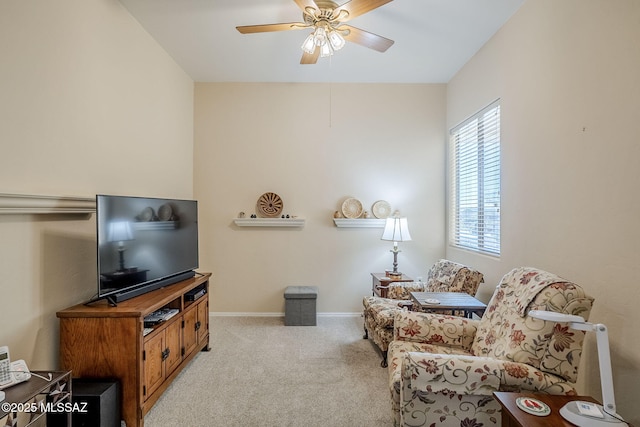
[471,267,593,382]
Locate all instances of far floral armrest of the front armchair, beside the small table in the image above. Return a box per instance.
[393,311,480,351]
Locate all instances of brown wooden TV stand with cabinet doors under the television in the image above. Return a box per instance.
[57,273,211,427]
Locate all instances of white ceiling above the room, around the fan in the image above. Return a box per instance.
[120,0,524,83]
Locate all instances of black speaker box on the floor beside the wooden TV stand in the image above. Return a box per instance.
[71,378,122,427]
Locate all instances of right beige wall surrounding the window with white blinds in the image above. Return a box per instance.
[447,0,640,425]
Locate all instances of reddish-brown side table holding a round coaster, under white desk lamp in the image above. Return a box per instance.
[493,391,598,427]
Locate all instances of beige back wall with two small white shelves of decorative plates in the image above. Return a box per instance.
[195,83,445,314]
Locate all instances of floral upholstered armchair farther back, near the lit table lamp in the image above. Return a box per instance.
[362,259,483,367]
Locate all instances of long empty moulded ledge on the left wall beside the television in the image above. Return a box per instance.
[0,193,96,215]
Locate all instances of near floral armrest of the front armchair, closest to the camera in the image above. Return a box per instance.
[401,352,576,396]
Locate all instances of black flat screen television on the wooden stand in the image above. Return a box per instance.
[96,194,198,304]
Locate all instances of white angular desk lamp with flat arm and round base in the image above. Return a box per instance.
[529,310,628,427]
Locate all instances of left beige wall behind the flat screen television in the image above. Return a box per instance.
[0,0,193,369]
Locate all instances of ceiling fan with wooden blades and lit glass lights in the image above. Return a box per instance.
[236,0,393,64]
